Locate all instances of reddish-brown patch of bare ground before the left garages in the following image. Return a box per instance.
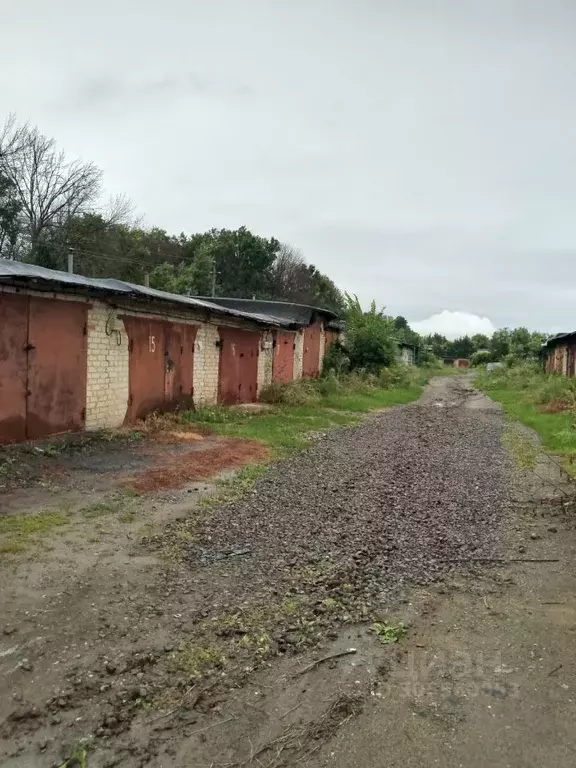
[122,438,270,493]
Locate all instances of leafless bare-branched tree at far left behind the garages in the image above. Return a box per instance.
[0,120,102,258]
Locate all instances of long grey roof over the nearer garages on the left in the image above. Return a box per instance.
[0,259,292,327]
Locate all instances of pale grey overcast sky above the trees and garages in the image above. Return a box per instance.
[0,0,576,334]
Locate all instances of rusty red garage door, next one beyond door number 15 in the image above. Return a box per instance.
[218,327,260,405]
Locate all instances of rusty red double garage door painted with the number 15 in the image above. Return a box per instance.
[123,316,197,423]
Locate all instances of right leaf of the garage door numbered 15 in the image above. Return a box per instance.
[164,323,197,408]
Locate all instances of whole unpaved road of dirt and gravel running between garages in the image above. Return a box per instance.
[0,377,576,768]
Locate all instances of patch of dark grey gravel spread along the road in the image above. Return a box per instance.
[192,379,510,616]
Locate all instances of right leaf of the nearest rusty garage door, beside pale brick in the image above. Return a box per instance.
[26,296,87,438]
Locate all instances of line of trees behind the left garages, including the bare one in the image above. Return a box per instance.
[0,116,343,311]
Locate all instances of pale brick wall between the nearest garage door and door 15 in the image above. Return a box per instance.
[86,303,129,429]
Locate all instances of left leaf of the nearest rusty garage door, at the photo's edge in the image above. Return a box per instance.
[0,293,28,443]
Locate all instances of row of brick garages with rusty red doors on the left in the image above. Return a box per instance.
[0,260,339,443]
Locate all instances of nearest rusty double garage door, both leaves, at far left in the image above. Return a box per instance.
[0,295,86,442]
